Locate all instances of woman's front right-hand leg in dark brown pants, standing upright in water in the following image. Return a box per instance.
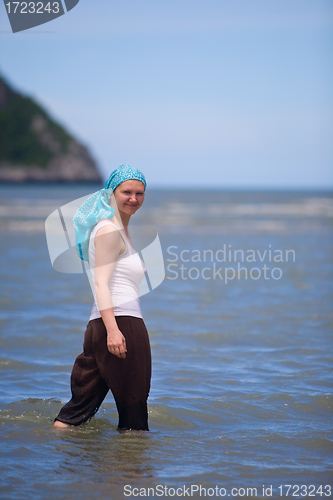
[93,316,151,430]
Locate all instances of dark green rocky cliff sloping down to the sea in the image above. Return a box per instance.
[0,77,101,182]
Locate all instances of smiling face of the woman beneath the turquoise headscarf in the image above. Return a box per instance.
[114,179,145,215]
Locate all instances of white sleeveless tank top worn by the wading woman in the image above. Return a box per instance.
[89,220,146,320]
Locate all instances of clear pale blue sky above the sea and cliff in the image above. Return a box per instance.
[0,0,333,189]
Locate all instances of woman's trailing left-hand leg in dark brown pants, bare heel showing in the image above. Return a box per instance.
[55,320,109,427]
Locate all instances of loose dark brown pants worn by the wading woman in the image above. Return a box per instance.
[55,316,151,431]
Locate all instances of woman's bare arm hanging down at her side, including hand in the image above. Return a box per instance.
[95,224,127,358]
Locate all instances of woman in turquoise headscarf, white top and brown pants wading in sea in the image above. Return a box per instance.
[54,165,151,430]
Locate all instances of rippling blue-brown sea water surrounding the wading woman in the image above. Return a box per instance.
[0,185,333,500]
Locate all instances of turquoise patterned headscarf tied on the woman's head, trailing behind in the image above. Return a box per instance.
[73,165,146,262]
